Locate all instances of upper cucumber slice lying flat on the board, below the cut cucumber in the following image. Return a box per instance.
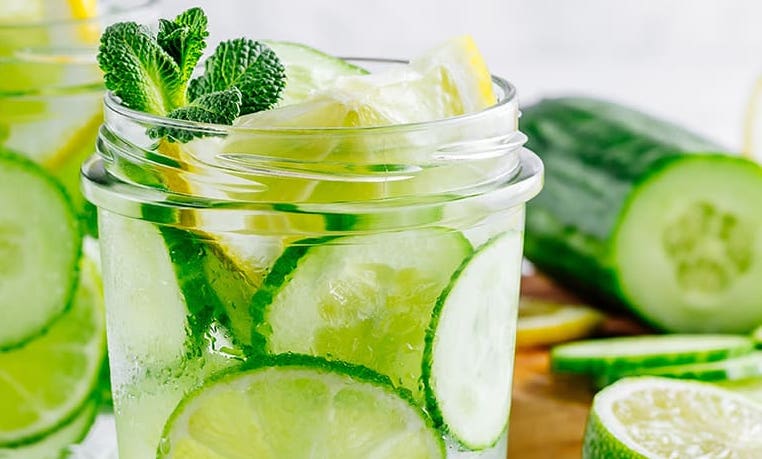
[550,335,754,375]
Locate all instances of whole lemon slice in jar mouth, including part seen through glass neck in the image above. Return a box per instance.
[222,36,497,203]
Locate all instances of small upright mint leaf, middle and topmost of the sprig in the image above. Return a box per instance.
[156,8,209,82]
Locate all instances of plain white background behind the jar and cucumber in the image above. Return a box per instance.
[154,0,762,150]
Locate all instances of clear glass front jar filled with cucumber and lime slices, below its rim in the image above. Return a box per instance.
[83,69,542,459]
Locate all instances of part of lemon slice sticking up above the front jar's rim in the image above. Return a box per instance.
[233,36,496,131]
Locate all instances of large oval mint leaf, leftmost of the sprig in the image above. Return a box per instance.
[98,22,185,115]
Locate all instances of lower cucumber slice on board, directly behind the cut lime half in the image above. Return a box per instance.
[596,352,762,387]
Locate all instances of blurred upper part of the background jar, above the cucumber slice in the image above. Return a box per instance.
[0,0,157,232]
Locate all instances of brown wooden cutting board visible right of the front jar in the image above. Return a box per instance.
[508,276,648,459]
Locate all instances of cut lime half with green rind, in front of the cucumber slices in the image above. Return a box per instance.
[582,377,762,459]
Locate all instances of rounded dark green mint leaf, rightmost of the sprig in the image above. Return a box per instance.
[188,38,286,115]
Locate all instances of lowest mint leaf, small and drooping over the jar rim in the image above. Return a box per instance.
[149,88,241,143]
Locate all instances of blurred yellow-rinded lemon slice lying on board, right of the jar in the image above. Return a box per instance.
[516,298,603,346]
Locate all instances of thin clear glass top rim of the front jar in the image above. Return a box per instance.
[104,65,518,136]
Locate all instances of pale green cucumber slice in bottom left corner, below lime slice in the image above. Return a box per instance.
[0,400,98,459]
